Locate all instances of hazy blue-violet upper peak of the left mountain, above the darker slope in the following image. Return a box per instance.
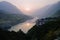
[0,1,22,14]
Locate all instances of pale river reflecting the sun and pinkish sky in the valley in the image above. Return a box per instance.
[9,18,38,33]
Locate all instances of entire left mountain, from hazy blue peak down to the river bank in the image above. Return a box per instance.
[0,1,31,29]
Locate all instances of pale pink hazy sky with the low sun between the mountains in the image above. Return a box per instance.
[0,0,59,12]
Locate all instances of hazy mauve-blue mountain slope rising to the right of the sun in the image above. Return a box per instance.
[33,2,60,18]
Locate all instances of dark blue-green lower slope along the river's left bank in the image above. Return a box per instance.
[0,11,31,29]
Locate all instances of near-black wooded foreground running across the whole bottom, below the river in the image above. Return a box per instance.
[0,17,60,40]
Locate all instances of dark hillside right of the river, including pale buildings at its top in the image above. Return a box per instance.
[27,10,60,40]
